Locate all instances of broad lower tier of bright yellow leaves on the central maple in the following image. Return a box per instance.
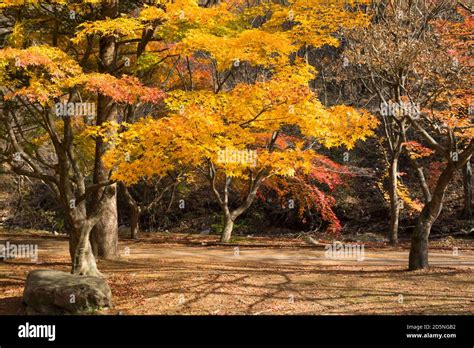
[101,71,377,183]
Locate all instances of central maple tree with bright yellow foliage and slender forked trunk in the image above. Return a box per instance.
[100,1,376,242]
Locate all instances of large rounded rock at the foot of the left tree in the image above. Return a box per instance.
[23,270,112,314]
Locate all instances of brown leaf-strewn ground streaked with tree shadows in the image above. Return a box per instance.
[0,230,474,315]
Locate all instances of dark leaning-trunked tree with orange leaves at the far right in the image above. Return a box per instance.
[409,4,474,270]
